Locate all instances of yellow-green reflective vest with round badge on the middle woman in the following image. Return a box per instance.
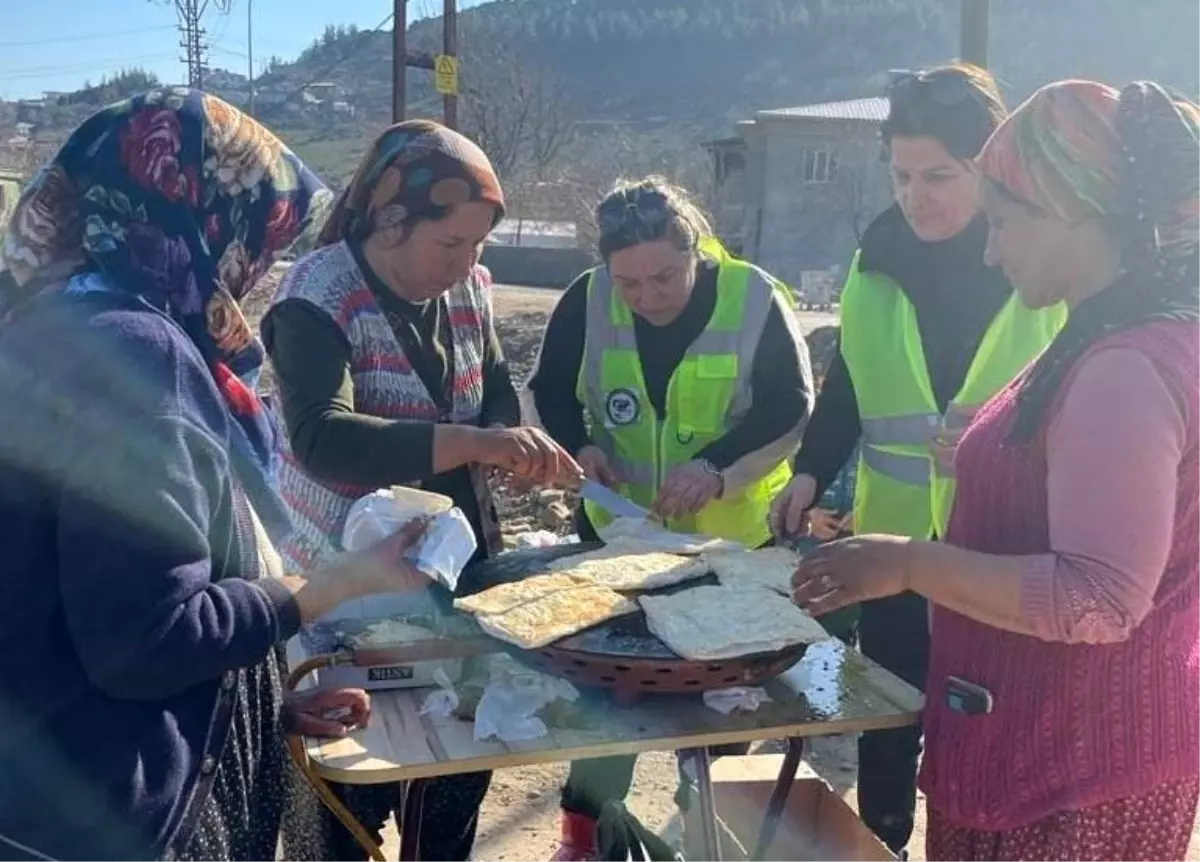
[577,257,791,545]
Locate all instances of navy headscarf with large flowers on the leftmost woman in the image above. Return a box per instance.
[0,89,332,529]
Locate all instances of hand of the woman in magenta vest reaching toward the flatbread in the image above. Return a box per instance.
[792,535,916,617]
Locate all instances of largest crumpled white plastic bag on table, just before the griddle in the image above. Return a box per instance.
[475,656,580,742]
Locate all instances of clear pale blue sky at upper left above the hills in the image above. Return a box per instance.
[0,0,482,100]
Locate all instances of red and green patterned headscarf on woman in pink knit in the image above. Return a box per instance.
[979,80,1200,442]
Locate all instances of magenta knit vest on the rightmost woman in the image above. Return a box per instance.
[920,323,1200,831]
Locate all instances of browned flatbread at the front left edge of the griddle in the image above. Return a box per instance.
[475,587,637,650]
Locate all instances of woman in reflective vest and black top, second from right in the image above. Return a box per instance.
[773,64,1062,851]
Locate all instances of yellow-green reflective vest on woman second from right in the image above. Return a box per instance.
[841,256,1067,539]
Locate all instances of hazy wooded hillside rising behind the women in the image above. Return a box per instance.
[9,0,1200,207]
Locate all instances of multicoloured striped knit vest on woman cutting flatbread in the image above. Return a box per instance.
[276,243,492,570]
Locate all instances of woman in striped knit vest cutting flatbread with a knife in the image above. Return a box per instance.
[263,120,581,862]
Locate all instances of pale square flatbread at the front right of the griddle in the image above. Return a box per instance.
[638,586,829,662]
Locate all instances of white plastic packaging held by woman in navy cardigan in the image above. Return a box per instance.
[342,487,478,592]
